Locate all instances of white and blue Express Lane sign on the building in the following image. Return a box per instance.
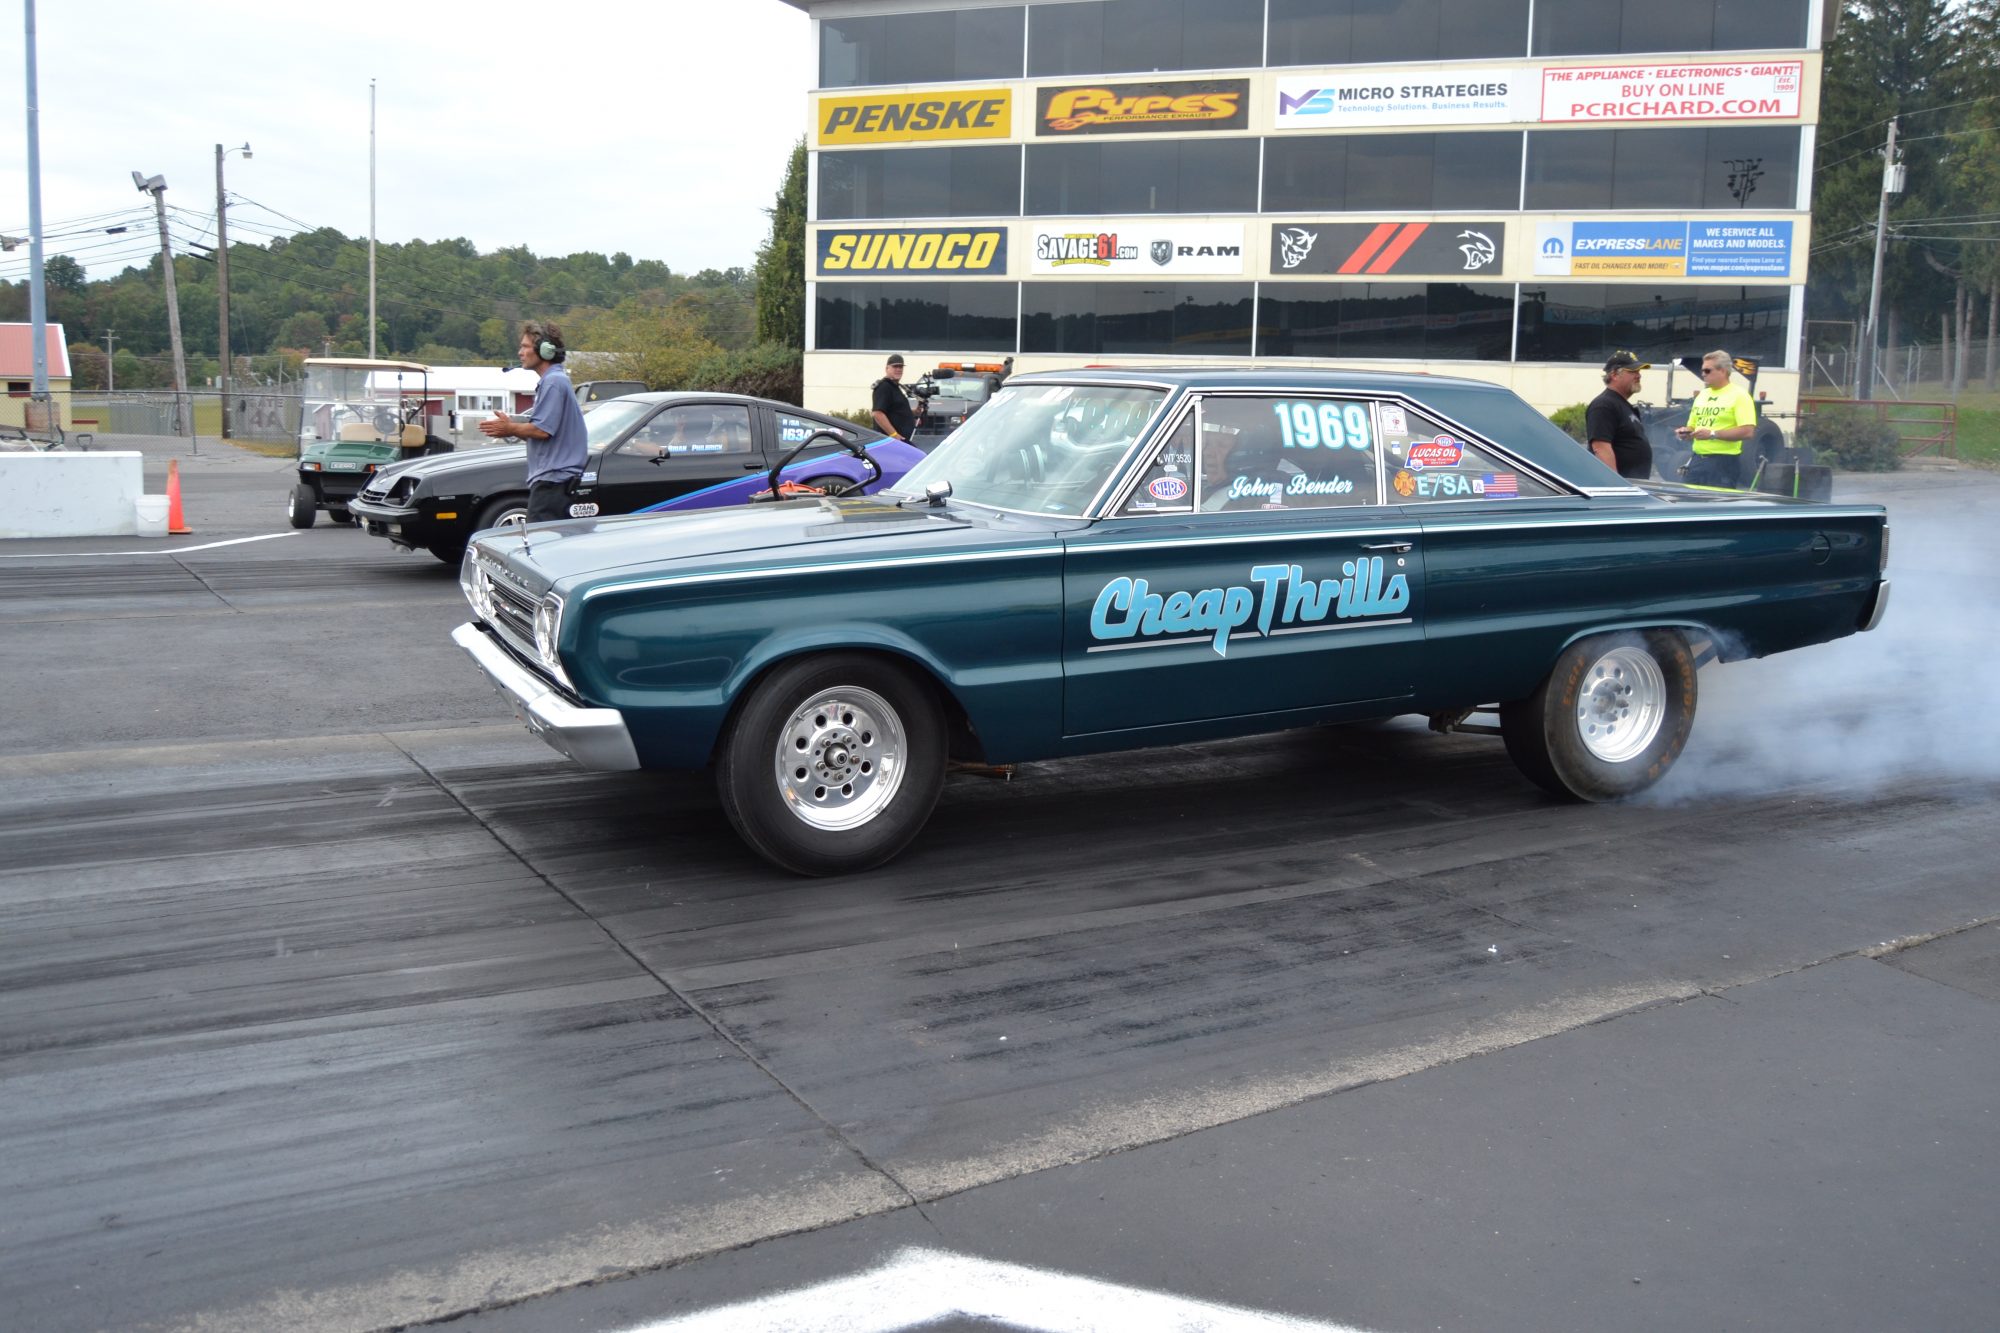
[1534,218,1792,278]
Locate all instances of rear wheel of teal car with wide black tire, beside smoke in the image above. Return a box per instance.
[1500,630,1696,801]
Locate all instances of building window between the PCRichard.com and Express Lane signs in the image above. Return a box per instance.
[1524,126,1798,212]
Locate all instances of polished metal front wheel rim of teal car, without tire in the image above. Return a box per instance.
[774,685,908,831]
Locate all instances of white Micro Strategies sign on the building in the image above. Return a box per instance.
[1276,66,1542,130]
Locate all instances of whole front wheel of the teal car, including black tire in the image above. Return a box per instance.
[716,652,944,875]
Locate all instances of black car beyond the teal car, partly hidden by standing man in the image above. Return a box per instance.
[348,392,888,564]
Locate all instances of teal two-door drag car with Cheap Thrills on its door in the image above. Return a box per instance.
[454,368,1888,875]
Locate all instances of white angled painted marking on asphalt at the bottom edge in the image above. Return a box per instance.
[626,1247,1362,1333]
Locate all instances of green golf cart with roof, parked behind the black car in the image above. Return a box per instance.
[286,356,452,528]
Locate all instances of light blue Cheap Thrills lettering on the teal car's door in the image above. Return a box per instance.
[1090,556,1410,656]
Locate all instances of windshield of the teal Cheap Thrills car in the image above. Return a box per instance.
[896,384,1166,514]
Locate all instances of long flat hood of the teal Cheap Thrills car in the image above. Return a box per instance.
[478,498,1058,590]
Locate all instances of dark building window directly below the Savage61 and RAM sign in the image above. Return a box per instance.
[1020,280,1250,356]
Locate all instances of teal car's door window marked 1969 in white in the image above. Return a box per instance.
[1200,394,1376,512]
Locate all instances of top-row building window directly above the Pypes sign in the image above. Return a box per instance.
[1028,0,1264,78]
